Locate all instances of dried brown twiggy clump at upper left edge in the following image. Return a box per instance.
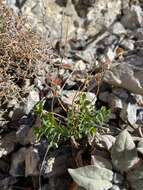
[0,3,49,104]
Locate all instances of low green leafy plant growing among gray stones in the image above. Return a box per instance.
[34,93,110,147]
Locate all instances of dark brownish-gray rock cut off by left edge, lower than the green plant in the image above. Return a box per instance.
[0,132,16,158]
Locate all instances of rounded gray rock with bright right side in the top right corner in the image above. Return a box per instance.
[122,5,143,30]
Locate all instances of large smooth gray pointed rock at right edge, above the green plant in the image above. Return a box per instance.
[103,56,143,95]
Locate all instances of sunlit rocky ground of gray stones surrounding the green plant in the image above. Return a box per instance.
[0,0,143,190]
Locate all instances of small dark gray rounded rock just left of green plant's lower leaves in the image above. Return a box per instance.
[16,125,35,145]
